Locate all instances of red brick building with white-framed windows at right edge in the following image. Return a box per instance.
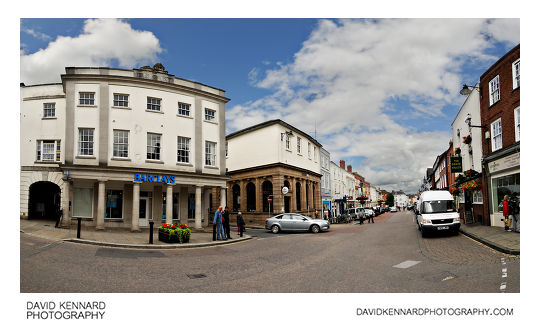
[480,45,520,226]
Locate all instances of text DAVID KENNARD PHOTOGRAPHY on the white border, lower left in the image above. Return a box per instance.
[26,301,106,319]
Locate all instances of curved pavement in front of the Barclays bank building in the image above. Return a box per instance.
[20,219,252,249]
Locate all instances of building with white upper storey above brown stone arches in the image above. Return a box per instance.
[225,119,322,224]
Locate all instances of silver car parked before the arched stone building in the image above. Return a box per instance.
[265,213,330,233]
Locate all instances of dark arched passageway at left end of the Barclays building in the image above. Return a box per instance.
[28,181,60,220]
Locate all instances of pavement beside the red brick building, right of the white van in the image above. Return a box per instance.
[459,224,520,255]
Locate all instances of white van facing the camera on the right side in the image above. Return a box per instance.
[416,190,461,237]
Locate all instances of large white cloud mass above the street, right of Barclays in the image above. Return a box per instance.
[227,19,519,191]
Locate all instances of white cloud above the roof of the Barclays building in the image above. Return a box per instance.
[21,19,162,84]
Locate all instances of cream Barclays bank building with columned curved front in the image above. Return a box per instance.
[20,64,229,231]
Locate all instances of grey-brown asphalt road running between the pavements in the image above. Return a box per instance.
[20,212,520,293]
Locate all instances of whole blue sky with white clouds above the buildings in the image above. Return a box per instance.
[20,18,520,193]
